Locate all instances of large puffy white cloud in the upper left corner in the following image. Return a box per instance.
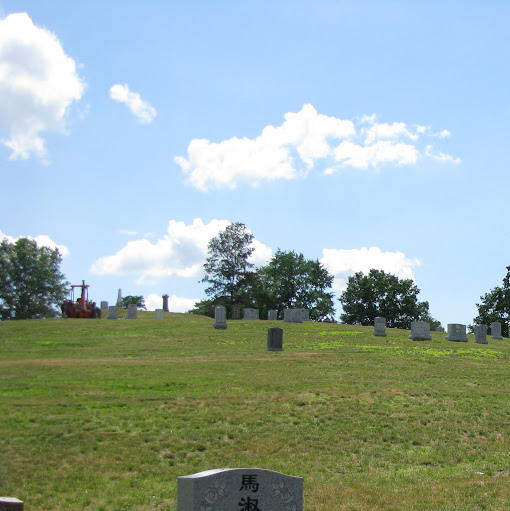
[0,13,85,159]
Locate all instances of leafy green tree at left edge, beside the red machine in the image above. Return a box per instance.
[0,238,69,319]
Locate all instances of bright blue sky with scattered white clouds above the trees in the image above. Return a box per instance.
[0,0,510,326]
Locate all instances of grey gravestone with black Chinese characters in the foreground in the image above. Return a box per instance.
[177,468,303,511]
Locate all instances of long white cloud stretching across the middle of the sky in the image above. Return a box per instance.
[175,105,456,191]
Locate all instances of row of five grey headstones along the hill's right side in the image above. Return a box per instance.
[374,317,503,344]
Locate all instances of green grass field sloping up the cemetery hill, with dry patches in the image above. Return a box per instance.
[0,312,510,511]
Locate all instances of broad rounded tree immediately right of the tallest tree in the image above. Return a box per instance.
[253,250,335,319]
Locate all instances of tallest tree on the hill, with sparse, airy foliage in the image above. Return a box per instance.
[201,223,254,310]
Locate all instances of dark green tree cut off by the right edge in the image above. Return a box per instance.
[473,266,510,337]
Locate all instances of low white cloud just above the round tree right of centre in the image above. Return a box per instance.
[321,247,421,292]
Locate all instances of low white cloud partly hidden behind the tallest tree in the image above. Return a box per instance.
[91,218,271,283]
